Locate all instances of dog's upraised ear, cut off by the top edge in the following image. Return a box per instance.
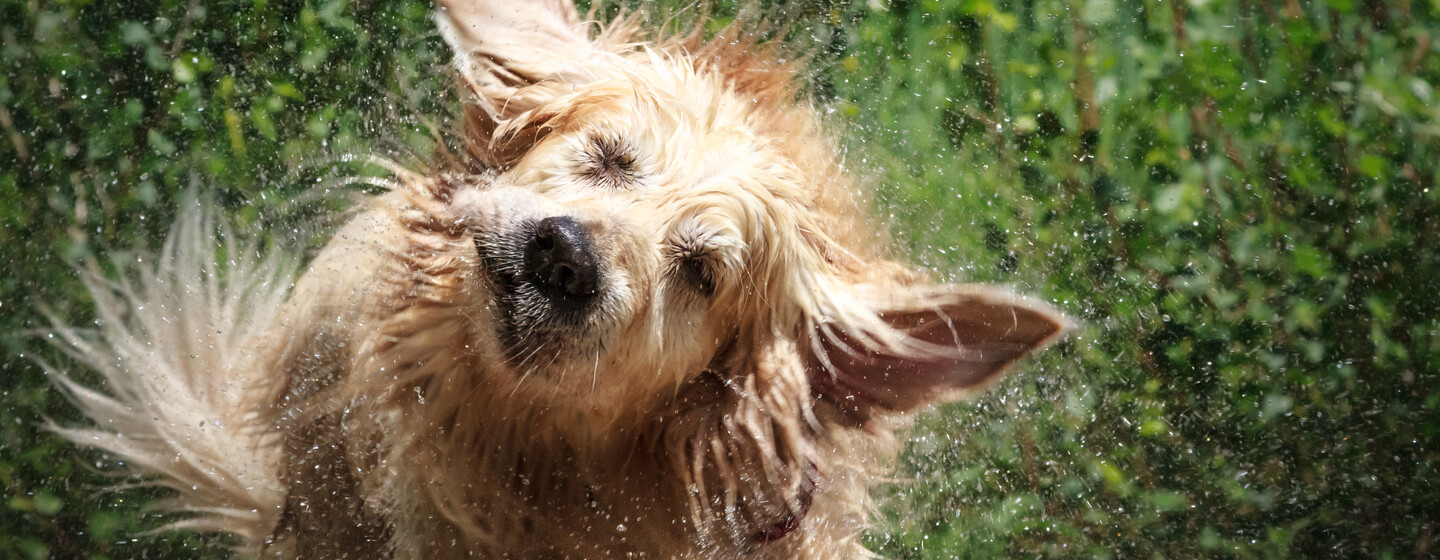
[435,0,613,167]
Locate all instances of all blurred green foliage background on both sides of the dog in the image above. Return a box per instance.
[0,0,1440,559]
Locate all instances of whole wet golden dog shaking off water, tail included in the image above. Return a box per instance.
[46,0,1070,559]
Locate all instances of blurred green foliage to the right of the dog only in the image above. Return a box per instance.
[828,0,1440,559]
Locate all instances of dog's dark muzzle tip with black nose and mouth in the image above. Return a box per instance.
[474,216,608,370]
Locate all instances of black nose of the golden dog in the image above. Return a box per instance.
[524,216,600,304]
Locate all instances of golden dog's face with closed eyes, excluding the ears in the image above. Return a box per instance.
[455,70,801,399]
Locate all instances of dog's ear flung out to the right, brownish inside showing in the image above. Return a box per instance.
[809,285,1070,423]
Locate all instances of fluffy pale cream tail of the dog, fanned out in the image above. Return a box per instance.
[42,202,295,543]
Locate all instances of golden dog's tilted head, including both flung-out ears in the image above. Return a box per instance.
[377,0,1066,431]
